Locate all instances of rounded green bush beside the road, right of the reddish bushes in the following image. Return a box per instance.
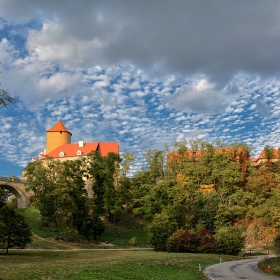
[216,227,245,255]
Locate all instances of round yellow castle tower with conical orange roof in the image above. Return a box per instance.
[46,121,72,154]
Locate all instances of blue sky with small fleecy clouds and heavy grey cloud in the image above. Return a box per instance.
[0,0,280,176]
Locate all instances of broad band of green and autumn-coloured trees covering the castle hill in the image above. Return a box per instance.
[21,140,280,254]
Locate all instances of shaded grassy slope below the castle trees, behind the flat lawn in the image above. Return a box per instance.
[18,206,151,249]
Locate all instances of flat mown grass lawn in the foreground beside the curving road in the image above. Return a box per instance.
[0,249,241,280]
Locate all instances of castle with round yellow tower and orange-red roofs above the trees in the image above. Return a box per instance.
[32,120,119,161]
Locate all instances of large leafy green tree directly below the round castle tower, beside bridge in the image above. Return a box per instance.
[24,158,89,235]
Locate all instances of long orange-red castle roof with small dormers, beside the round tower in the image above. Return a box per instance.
[47,142,119,158]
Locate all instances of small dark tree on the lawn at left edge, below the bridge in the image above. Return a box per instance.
[0,206,32,254]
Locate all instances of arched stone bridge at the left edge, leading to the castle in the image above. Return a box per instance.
[0,177,33,208]
